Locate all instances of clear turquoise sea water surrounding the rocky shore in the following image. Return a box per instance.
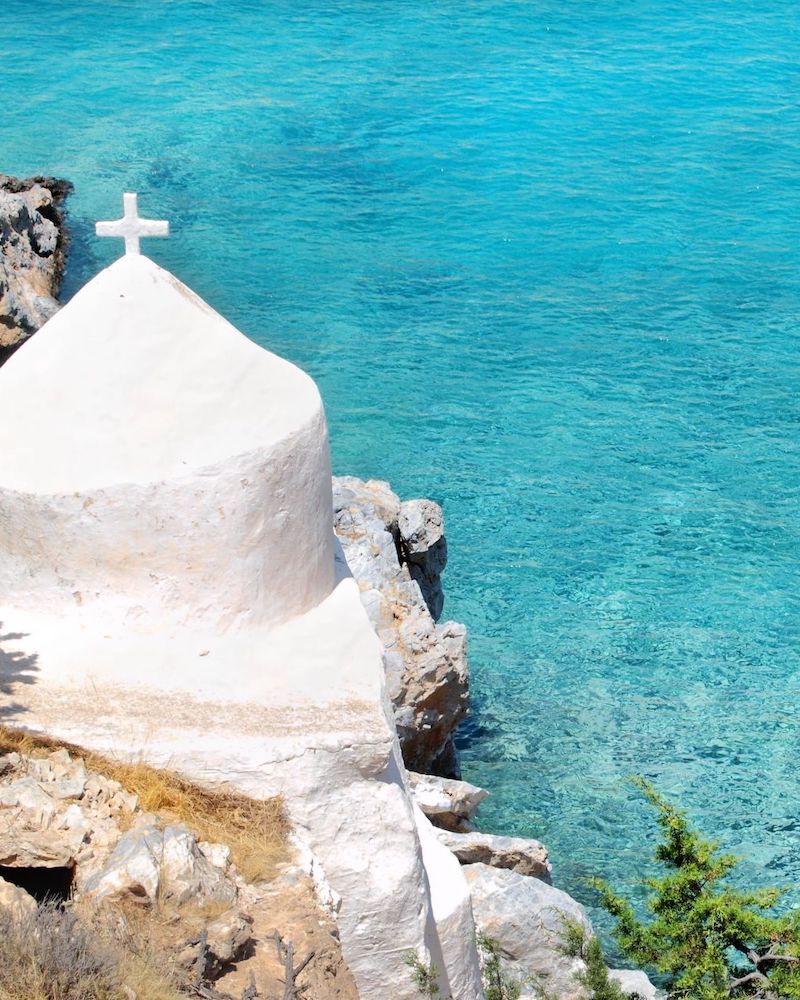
[0,0,800,936]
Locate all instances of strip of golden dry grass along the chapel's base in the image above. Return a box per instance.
[0,726,290,884]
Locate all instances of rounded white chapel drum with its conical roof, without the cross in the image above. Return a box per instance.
[0,253,335,634]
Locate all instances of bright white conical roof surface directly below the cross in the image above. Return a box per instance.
[0,254,320,493]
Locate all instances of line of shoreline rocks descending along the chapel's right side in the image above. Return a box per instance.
[333,476,656,1000]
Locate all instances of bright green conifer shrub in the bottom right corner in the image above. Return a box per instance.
[593,778,800,1000]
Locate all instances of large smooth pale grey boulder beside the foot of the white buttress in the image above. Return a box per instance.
[462,864,591,1000]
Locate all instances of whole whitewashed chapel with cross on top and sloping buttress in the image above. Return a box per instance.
[0,195,482,1000]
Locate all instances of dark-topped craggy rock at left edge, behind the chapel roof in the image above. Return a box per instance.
[0,174,72,364]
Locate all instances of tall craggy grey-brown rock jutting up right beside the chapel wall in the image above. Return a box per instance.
[333,476,469,777]
